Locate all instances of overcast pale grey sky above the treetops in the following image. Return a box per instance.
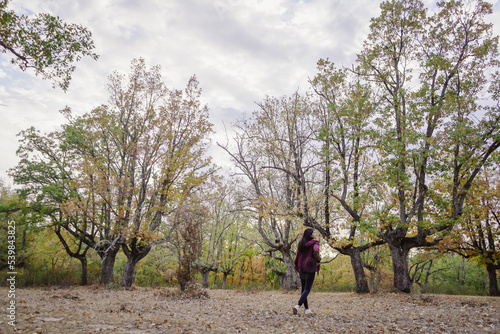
[0,0,500,184]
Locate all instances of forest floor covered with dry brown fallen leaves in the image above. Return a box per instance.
[0,286,500,334]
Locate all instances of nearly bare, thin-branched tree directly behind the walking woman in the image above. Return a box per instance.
[219,93,314,289]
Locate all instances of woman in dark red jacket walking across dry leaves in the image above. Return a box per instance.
[293,228,321,314]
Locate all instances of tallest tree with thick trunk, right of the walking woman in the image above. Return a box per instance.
[358,0,500,292]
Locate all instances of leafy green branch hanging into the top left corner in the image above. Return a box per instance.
[0,0,98,91]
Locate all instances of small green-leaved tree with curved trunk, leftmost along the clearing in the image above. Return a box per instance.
[10,127,97,285]
